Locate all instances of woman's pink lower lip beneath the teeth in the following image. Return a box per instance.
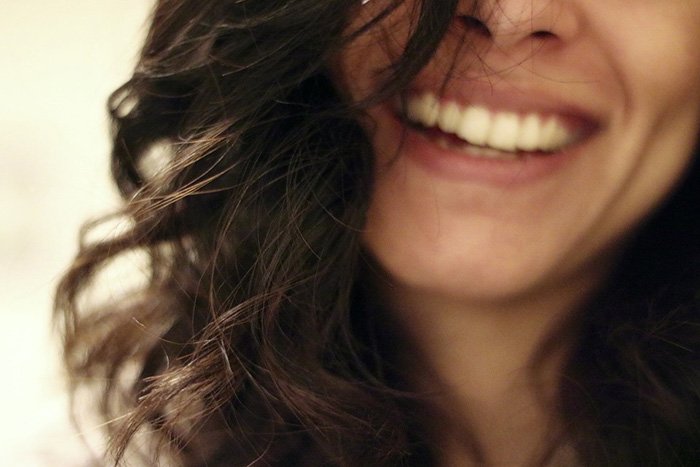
[381,108,583,187]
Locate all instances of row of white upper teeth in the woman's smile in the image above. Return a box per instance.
[406,93,576,152]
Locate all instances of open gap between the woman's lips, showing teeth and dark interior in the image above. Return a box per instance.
[403,92,593,159]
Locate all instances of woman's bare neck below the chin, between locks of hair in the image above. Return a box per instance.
[381,268,602,467]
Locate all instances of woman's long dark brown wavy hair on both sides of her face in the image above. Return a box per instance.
[56,0,700,467]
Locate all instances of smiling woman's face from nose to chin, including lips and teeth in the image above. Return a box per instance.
[340,0,700,300]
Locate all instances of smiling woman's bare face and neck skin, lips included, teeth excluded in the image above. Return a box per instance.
[337,0,700,466]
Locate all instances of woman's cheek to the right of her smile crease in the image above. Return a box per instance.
[596,14,700,230]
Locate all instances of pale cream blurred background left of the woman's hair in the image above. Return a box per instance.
[0,0,152,467]
